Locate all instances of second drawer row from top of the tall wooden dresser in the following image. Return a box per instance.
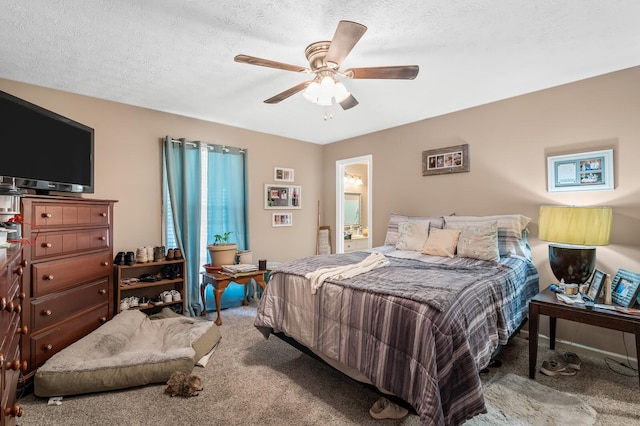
[31,228,110,260]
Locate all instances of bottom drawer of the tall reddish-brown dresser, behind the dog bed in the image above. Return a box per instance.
[30,304,109,369]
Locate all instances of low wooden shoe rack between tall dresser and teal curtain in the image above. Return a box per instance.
[114,259,186,314]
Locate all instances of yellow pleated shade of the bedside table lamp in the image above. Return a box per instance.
[538,206,613,246]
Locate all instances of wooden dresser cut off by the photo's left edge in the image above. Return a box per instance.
[0,244,28,426]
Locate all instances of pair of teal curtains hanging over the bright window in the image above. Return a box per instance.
[163,136,249,316]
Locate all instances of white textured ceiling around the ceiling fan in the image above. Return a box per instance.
[0,0,640,144]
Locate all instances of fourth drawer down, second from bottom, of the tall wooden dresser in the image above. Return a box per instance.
[31,278,111,333]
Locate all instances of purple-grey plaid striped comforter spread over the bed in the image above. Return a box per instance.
[255,250,538,425]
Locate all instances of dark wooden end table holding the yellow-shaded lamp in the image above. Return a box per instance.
[529,288,640,385]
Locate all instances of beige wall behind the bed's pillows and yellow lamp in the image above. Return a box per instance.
[323,67,640,356]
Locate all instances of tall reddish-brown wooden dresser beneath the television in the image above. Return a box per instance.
[21,195,114,381]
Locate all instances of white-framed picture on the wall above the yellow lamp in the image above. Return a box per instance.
[547,149,614,192]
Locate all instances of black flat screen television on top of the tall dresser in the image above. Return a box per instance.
[0,91,94,194]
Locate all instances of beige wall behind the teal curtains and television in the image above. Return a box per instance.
[0,79,322,261]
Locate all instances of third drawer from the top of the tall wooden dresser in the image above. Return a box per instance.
[31,252,112,299]
